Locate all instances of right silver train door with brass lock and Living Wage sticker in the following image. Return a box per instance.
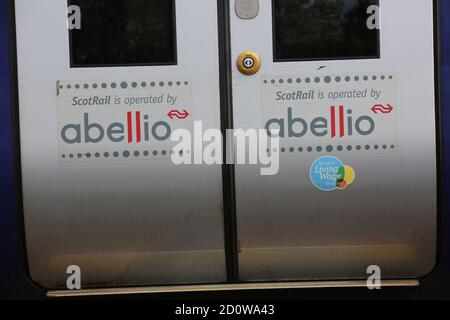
[230,0,437,281]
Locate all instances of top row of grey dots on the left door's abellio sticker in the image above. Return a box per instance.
[59,80,190,90]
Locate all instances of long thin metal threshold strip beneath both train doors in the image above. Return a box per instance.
[47,280,420,298]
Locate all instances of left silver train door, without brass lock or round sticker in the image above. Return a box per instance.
[15,0,226,288]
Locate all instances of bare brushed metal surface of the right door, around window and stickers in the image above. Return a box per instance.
[231,0,437,281]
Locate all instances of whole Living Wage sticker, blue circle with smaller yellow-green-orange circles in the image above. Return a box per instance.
[309,156,356,191]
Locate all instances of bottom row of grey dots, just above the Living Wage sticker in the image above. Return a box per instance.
[266,144,396,153]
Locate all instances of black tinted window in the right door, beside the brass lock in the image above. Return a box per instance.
[273,0,379,61]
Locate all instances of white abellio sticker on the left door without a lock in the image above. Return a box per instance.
[57,79,193,161]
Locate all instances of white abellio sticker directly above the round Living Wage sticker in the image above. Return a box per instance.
[262,72,398,153]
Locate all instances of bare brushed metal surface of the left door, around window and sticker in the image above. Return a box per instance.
[15,0,226,288]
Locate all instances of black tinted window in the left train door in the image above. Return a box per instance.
[68,0,176,67]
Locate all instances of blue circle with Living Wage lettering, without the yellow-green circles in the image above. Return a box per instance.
[309,156,344,191]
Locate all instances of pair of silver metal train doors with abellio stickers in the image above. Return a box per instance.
[13,0,437,288]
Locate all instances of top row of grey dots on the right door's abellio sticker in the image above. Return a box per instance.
[263,74,394,85]
